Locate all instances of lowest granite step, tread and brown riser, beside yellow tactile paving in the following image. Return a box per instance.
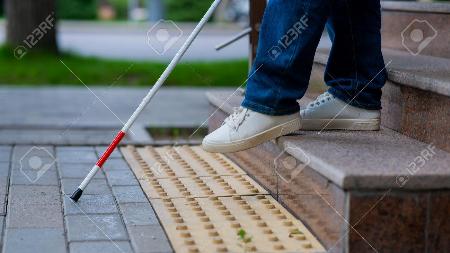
[207,90,450,253]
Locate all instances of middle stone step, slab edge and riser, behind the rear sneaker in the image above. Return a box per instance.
[311,49,450,151]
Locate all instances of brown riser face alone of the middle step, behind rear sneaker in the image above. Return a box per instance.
[311,63,450,151]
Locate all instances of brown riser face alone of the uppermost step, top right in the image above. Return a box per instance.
[382,10,450,58]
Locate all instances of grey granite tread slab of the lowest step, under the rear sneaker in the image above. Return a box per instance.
[207,92,450,191]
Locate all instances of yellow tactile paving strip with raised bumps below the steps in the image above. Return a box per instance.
[122,146,325,253]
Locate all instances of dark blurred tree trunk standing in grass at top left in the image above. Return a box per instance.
[5,0,58,51]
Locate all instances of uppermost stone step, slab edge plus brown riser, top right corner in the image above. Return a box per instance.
[382,1,450,58]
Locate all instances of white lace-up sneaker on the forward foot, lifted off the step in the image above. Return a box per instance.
[202,107,300,153]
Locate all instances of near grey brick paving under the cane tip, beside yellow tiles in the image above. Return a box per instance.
[0,145,172,253]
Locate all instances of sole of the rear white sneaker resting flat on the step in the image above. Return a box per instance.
[301,119,380,131]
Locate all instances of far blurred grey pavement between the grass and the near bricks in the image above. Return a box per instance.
[0,87,232,145]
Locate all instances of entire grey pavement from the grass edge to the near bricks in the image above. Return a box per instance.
[0,87,232,253]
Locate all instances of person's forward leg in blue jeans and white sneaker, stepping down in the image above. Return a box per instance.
[202,0,333,153]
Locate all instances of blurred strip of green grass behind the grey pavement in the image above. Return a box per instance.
[0,47,248,87]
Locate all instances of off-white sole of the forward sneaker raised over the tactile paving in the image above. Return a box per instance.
[202,119,301,153]
